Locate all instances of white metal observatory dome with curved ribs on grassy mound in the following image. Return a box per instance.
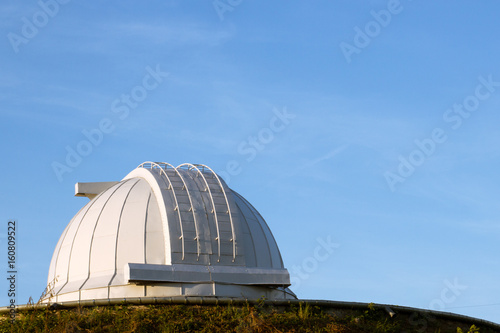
[43,162,296,303]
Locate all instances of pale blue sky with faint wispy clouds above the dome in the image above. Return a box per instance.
[0,0,500,323]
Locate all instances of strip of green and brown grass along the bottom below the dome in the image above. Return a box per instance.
[0,302,493,333]
